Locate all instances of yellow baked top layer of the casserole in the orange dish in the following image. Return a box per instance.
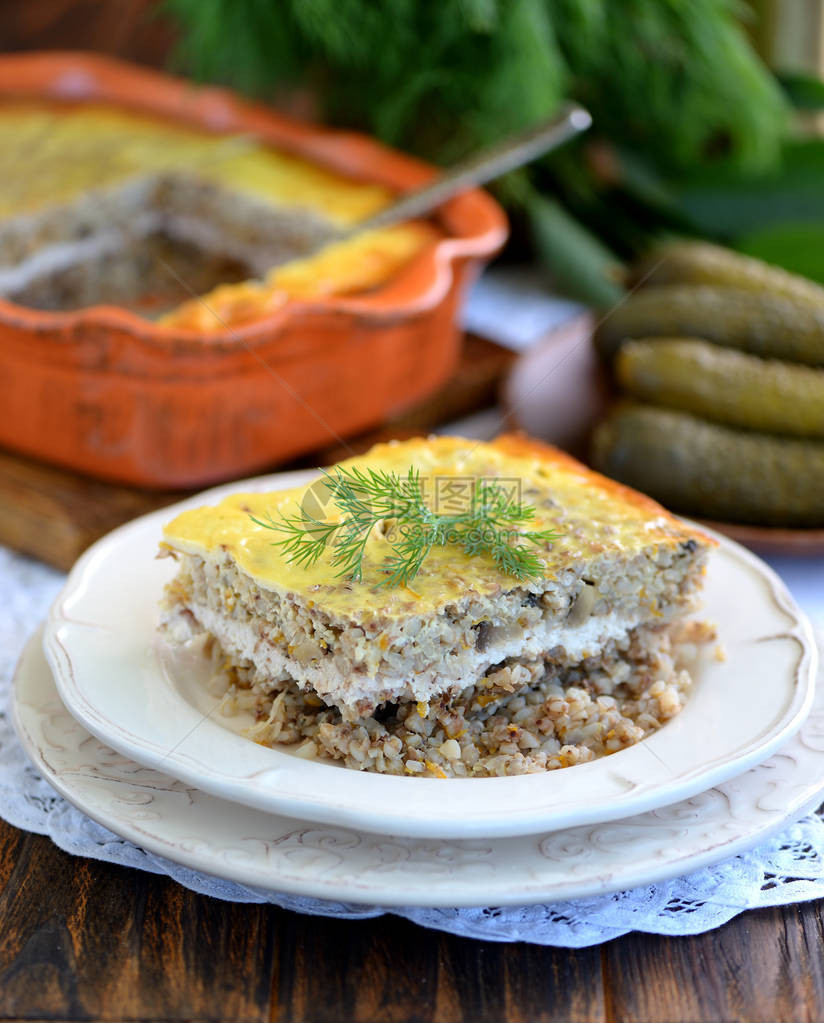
[0,104,439,323]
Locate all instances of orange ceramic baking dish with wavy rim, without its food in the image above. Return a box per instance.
[0,53,507,487]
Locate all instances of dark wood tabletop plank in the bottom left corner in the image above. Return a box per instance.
[0,821,275,1023]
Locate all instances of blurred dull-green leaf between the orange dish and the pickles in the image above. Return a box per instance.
[526,193,624,309]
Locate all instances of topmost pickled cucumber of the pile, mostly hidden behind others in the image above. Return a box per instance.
[630,241,824,306]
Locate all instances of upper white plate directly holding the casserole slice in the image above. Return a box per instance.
[45,474,816,838]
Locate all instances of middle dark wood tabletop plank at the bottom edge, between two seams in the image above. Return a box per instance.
[272,915,605,1023]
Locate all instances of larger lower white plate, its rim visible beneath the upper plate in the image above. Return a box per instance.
[12,634,824,906]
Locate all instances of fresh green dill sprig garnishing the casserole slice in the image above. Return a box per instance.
[251,466,558,587]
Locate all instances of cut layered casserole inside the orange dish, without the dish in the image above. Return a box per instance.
[0,100,439,330]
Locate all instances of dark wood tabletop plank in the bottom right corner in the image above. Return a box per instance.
[603,903,824,1023]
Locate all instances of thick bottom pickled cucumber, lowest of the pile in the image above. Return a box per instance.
[593,404,824,526]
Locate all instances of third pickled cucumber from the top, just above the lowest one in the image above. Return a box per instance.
[615,338,824,438]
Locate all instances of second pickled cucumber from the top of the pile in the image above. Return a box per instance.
[596,284,824,366]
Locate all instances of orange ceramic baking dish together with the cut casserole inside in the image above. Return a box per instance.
[0,53,507,488]
